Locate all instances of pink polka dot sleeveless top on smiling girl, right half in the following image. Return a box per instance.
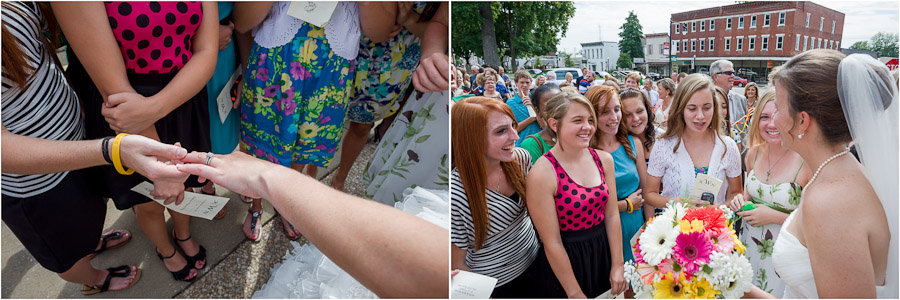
[544,149,609,231]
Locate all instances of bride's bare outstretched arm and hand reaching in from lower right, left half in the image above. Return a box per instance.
[178,152,450,298]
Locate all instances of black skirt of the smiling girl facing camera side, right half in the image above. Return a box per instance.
[533,222,612,299]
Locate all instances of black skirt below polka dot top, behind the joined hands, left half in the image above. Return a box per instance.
[66,50,212,210]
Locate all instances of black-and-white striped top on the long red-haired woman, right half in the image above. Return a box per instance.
[450,148,540,287]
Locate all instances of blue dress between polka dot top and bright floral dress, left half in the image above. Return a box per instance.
[206,2,241,154]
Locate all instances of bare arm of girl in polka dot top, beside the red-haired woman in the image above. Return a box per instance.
[525,157,585,298]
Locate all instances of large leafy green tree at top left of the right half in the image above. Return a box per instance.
[451,2,575,70]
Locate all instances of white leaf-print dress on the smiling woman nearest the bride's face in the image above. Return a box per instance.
[738,170,802,298]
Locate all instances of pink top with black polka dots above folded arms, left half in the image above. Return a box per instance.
[106,2,203,74]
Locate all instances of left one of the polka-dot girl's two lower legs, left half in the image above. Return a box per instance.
[134,201,197,280]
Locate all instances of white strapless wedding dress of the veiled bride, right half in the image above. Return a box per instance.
[772,210,889,299]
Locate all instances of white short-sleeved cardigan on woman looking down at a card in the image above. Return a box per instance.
[647,136,741,204]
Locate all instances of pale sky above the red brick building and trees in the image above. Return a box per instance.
[557,1,900,52]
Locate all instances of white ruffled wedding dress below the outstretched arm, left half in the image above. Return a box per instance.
[253,187,450,299]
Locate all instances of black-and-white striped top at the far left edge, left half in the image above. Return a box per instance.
[0,2,84,198]
